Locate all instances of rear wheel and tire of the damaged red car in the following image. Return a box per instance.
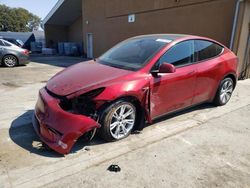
[214,78,234,106]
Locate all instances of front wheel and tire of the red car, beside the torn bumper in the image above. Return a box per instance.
[100,100,136,141]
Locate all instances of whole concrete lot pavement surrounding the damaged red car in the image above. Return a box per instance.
[0,58,250,188]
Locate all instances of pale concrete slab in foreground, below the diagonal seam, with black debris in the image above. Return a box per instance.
[46,105,250,188]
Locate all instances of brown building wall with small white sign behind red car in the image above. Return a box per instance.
[82,0,236,57]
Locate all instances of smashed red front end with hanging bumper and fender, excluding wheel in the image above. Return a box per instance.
[33,73,151,154]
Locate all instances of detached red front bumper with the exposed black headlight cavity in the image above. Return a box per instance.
[33,88,102,154]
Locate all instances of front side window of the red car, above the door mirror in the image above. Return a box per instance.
[155,40,194,68]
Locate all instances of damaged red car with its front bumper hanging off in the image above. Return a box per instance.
[33,34,238,154]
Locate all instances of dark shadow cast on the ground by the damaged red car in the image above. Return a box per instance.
[9,104,215,158]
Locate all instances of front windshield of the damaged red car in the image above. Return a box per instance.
[99,38,167,70]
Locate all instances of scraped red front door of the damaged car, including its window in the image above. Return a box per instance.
[150,40,196,118]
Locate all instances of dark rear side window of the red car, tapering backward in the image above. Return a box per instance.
[195,40,223,61]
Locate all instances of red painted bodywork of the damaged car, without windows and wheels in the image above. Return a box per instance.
[33,35,238,154]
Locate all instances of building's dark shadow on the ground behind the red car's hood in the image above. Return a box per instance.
[30,55,89,67]
